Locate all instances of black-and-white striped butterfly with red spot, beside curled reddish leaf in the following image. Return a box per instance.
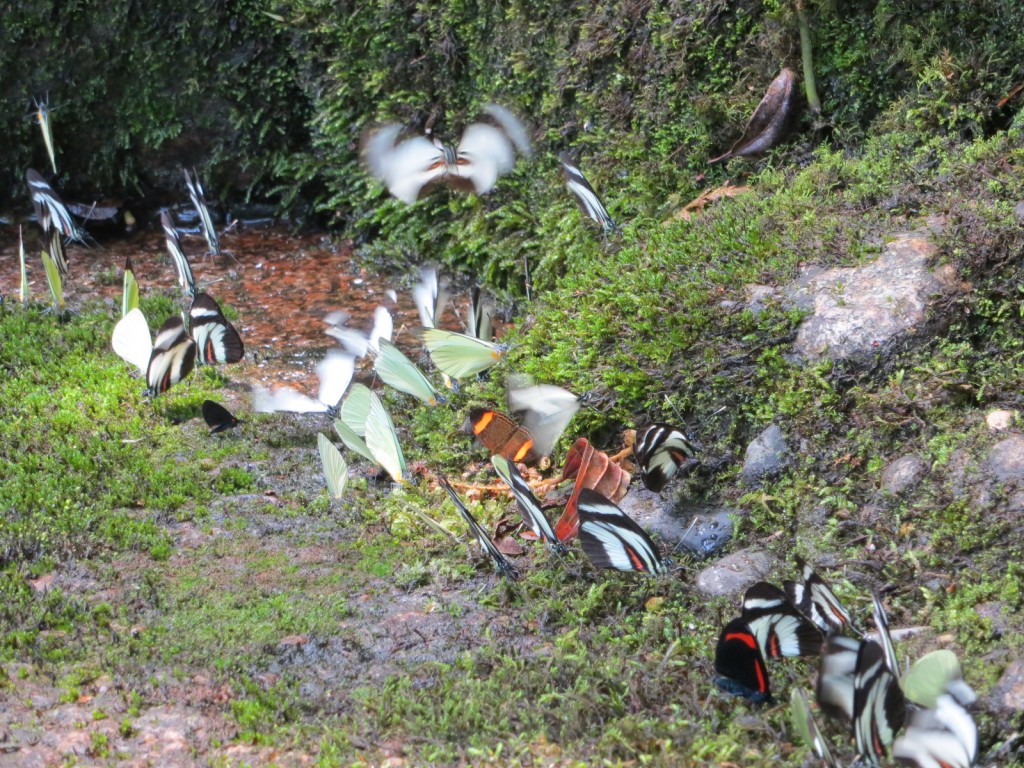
[577,488,669,575]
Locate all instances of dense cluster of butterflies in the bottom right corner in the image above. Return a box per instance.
[715,558,978,768]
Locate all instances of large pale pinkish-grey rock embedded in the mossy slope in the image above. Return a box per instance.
[786,222,959,365]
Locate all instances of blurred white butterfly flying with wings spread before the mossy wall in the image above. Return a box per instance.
[362,104,530,204]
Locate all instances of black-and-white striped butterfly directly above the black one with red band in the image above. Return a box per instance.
[742,582,821,658]
